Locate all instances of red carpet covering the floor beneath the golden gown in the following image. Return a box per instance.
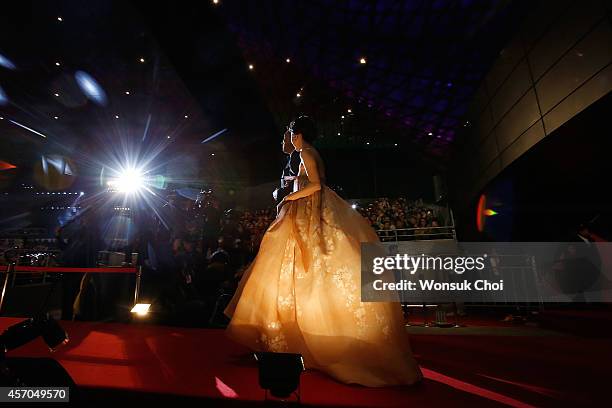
[0,318,612,407]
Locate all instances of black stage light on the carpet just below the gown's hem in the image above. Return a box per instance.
[255,352,304,401]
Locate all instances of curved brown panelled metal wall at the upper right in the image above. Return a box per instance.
[455,0,612,198]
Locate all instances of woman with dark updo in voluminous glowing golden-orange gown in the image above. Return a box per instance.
[225,116,422,387]
